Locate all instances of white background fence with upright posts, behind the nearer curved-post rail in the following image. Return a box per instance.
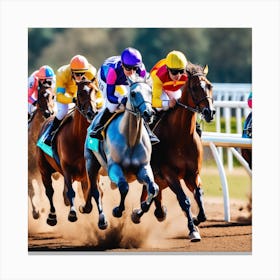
[213,83,252,171]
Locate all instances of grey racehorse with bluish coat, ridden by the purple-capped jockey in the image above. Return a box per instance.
[85,76,158,229]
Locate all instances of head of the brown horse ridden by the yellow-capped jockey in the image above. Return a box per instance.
[186,64,215,122]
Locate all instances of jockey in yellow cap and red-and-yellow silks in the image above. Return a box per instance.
[151,50,201,136]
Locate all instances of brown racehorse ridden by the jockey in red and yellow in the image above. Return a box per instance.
[131,63,215,241]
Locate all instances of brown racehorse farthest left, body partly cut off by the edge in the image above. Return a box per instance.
[28,84,54,219]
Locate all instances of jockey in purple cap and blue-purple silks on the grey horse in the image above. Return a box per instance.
[89,48,159,144]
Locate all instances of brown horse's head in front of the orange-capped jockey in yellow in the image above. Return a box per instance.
[76,80,97,122]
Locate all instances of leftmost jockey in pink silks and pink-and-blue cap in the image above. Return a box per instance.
[28,65,55,119]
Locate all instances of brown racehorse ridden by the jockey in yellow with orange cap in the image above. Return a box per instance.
[37,81,97,226]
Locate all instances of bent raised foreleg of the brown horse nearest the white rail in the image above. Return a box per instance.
[184,175,206,226]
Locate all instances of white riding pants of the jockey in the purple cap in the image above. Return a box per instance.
[97,69,129,113]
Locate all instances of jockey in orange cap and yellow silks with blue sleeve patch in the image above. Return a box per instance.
[45,55,103,145]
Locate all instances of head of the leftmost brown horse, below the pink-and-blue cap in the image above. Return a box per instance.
[37,84,54,119]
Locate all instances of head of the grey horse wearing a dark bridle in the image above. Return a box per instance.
[126,78,154,123]
